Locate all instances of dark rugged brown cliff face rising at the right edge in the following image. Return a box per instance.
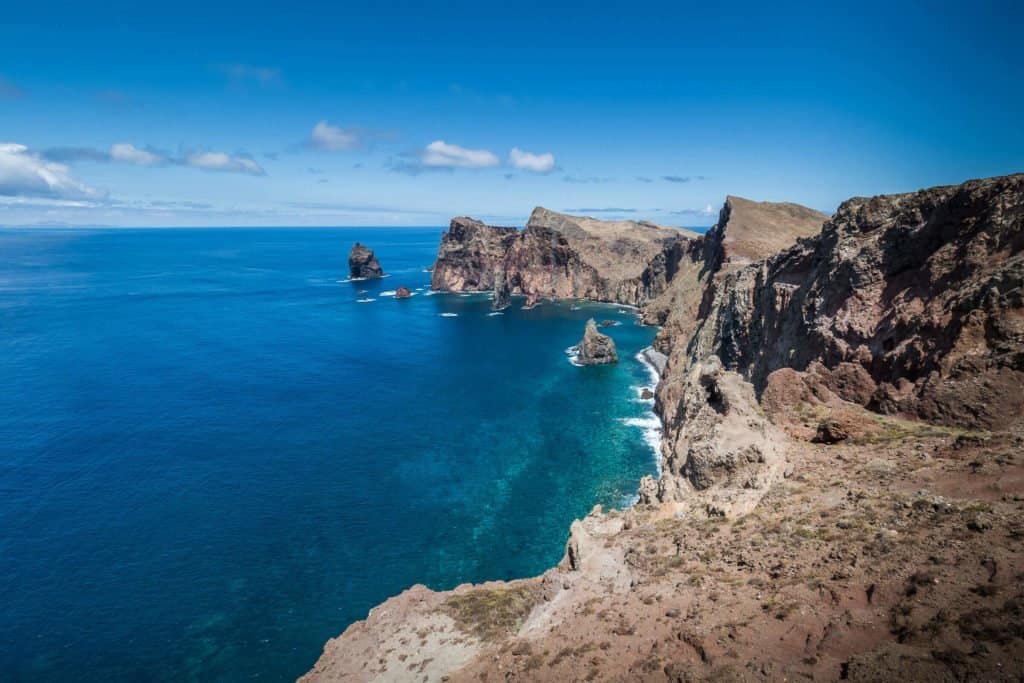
[686,175,1024,428]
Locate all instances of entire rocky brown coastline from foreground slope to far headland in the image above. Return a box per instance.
[306,175,1024,681]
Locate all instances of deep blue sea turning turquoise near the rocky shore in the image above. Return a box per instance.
[0,228,655,681]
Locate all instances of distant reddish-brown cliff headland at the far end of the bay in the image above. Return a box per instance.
[431,208,697,305]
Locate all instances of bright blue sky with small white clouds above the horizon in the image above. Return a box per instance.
[0,1,1024,225]
